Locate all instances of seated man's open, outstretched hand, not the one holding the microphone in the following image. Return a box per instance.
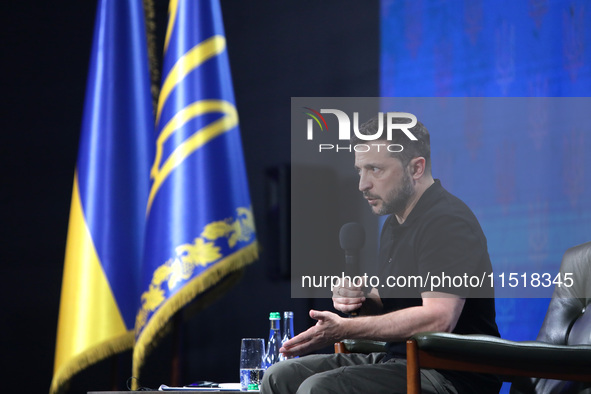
[279,310,346,357]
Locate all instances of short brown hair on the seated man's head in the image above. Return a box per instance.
[351,114,431,174]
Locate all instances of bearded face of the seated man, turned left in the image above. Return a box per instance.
[355,145,415,215]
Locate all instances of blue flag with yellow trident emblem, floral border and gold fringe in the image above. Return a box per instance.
[133,0,258,376]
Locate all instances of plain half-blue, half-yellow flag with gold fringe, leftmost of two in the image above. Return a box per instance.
[50,0,154,392]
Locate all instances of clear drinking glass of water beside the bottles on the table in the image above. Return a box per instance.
[240,338,265,391]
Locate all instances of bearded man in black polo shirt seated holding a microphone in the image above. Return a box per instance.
[261,118,500,394]
